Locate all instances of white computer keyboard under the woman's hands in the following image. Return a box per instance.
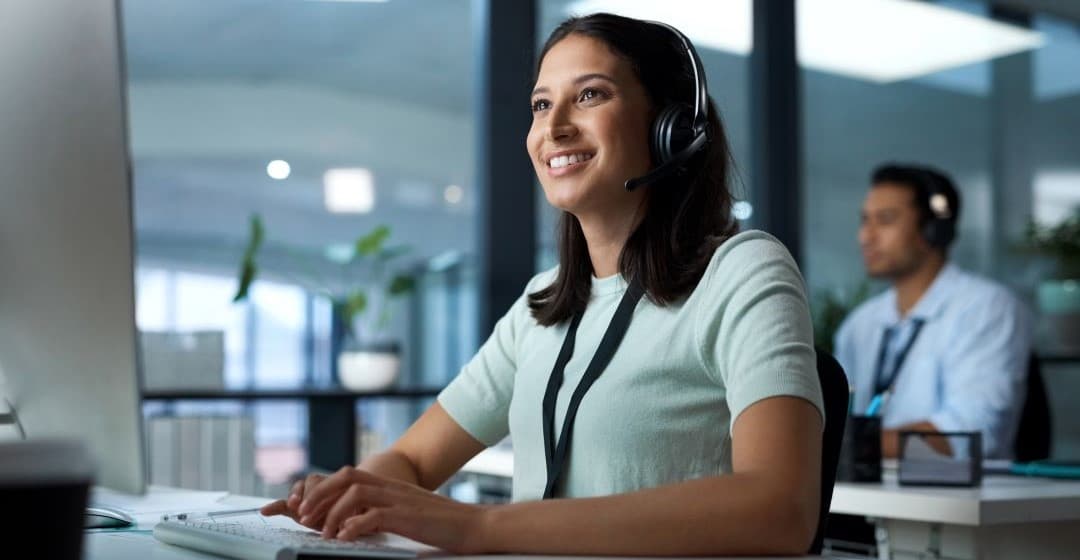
[153,521,417,560]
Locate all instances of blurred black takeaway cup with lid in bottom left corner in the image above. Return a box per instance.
[0,440,93,560]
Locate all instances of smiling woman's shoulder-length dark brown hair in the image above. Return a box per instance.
[529,14,739,326]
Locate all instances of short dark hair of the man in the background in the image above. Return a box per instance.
[870,163,960,249]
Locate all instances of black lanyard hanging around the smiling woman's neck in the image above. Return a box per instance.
[543,281,645,500]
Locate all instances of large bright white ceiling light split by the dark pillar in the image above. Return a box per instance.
[567,0,1044,83]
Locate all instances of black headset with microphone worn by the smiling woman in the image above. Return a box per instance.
[626,22,710,191]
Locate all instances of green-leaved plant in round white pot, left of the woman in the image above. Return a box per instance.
[233,215,416,392]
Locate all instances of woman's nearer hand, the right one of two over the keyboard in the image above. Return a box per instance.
[298,467,486,554]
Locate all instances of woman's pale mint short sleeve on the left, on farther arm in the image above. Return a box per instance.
[438,274,537,446]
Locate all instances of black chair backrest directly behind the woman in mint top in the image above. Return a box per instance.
[810,347,848,555]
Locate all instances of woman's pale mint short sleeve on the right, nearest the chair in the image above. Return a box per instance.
[697,232,825,427]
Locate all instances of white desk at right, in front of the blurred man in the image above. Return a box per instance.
[831,470,1080,560]
